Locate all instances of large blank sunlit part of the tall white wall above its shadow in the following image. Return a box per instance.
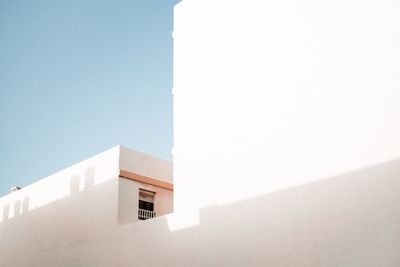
[173,0,400,211]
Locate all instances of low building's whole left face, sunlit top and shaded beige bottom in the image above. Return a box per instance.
[0,147,119,266]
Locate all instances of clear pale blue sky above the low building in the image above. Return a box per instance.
[0,0,176,196]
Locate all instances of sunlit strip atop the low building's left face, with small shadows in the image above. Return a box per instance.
[0,146,120,222]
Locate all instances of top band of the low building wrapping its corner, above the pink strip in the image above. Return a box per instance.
[0,146,172,222]
